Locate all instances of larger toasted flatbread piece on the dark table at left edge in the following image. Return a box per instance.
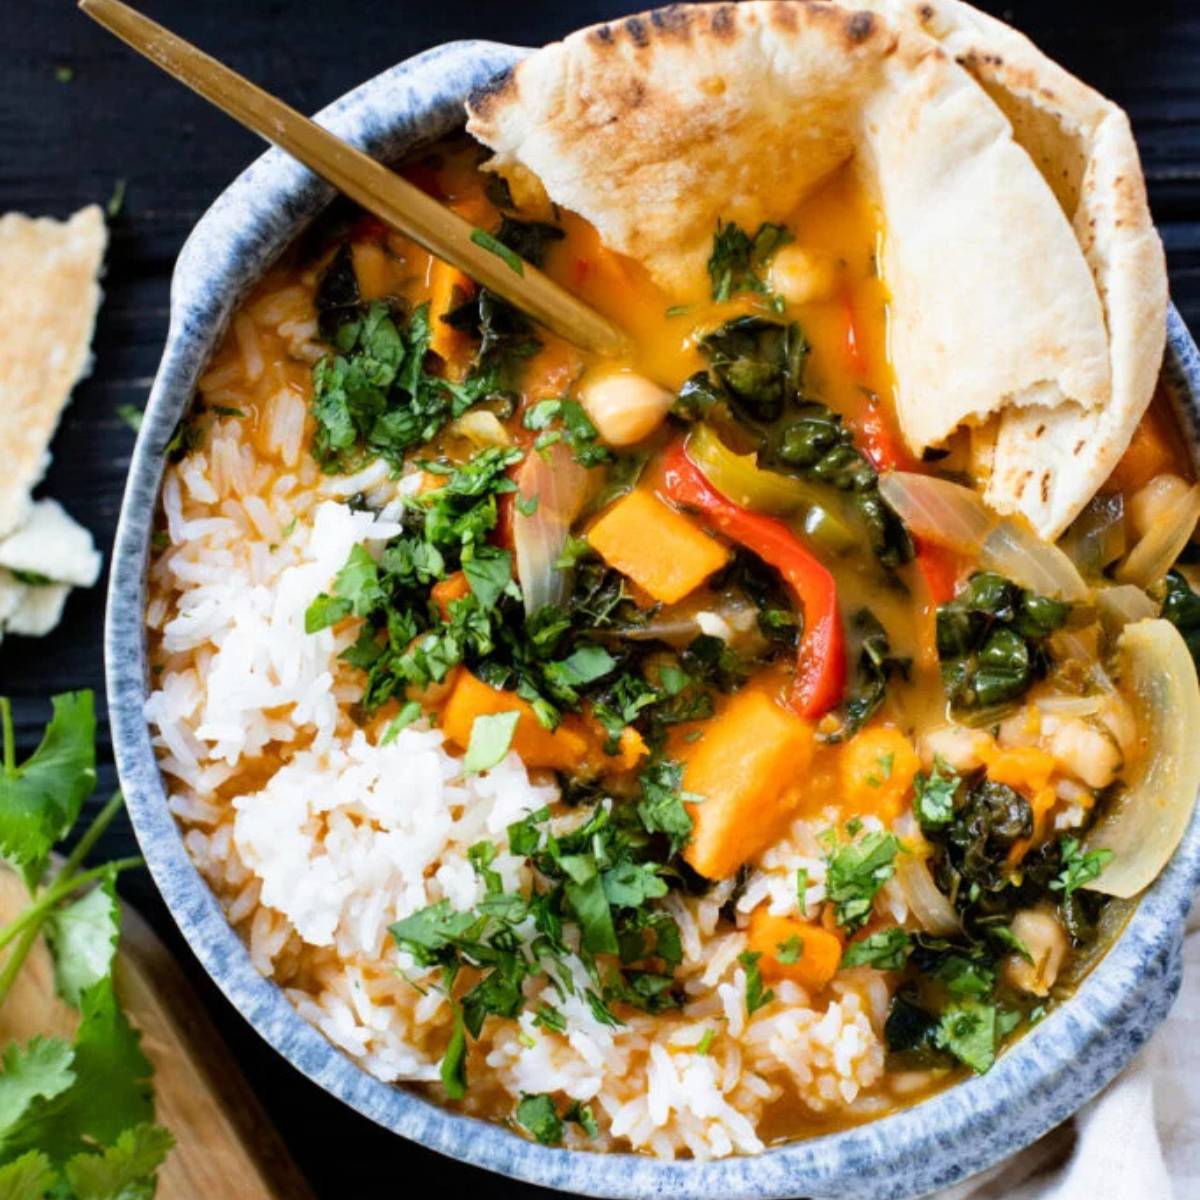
[0,205,108,535]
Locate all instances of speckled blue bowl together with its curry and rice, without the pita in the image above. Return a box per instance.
[107,5,1200,1198]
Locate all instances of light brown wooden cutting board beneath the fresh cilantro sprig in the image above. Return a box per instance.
[0,870,312,1200]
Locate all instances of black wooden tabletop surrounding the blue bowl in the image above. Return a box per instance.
[7,0,1200,1200]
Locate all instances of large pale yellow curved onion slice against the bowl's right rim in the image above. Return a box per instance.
[1085,619,1200,899]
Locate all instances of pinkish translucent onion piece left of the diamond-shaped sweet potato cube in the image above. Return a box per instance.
[512,442,592,617]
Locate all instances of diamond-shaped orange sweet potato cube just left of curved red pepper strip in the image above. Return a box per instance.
[587,487,730,604]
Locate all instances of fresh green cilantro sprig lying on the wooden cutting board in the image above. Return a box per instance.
[0,691,172,1200]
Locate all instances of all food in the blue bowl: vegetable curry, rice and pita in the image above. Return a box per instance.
[146,4,1200,1158]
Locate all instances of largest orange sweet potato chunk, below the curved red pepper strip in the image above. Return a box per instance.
[683,690,815,880]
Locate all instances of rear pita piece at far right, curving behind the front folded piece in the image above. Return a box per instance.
[856,0,1168,538]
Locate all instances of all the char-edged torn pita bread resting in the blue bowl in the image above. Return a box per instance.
[468,0,1166,538]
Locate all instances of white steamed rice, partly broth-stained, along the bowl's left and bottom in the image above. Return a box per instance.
[145,298,902,1159]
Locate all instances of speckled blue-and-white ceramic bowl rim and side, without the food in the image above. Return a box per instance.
[106,42,1200,1200]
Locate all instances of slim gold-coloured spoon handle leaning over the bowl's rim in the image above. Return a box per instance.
[79,0,629,358]
